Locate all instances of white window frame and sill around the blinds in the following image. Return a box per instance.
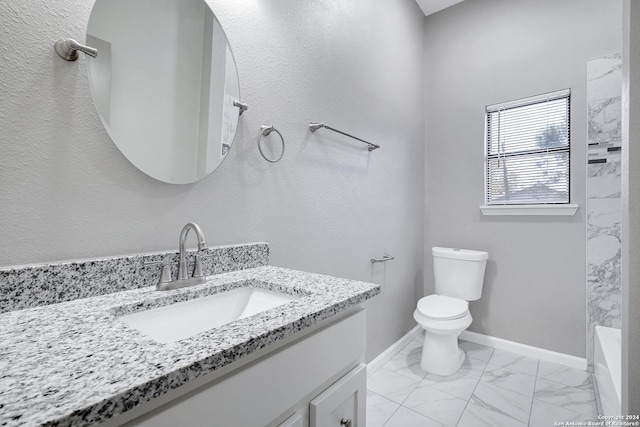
[480,89,578,215]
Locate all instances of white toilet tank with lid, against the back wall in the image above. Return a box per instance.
[431,248,489,301]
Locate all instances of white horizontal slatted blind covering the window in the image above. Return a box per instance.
[486,90,571,205]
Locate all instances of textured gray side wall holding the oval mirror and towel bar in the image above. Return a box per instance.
[0,0,425,359]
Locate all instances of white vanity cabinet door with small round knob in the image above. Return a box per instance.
[309,363,367,427]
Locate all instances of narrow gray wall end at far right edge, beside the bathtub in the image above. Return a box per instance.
[622,0,640,415]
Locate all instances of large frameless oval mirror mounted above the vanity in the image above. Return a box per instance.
[87,0,240,184]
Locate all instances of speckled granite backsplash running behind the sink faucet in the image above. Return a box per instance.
[0,243,269,313]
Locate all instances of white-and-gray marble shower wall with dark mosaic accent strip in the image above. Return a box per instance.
[587,54,622,370]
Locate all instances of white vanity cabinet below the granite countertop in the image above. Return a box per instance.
[103,308,366,427]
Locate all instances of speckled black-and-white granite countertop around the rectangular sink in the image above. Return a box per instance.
[0,266,380,426]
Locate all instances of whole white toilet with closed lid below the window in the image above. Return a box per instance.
[413,248,489,375]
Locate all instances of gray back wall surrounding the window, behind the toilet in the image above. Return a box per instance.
[425,0,621,357]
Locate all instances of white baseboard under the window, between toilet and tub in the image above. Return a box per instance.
[460,331,587,371]
